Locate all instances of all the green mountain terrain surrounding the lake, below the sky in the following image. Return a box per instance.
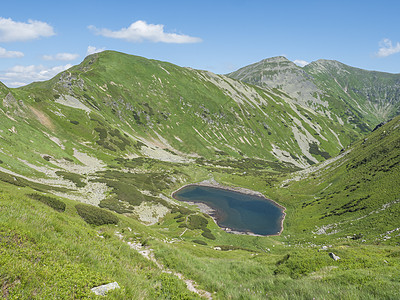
[0,51,400,299]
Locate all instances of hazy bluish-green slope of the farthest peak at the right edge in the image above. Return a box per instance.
[304,60,400,128]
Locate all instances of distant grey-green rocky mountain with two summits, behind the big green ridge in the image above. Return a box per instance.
[227,56,400,132]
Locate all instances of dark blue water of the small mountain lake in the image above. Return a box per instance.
[173,185,284,235]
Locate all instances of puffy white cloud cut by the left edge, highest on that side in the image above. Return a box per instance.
[0,17,55,42]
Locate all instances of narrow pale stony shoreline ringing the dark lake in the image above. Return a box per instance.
[171,180,286,236]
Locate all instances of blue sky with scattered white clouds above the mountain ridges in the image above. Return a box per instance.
[0,0,400,87]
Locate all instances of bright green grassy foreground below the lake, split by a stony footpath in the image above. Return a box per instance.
[0,168,400,299]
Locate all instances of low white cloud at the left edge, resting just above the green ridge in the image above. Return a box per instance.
[0,64,72,87]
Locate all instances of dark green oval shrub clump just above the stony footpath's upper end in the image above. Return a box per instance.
[75,204,119,226]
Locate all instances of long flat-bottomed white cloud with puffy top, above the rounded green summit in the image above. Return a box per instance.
[88,20,202,44]
